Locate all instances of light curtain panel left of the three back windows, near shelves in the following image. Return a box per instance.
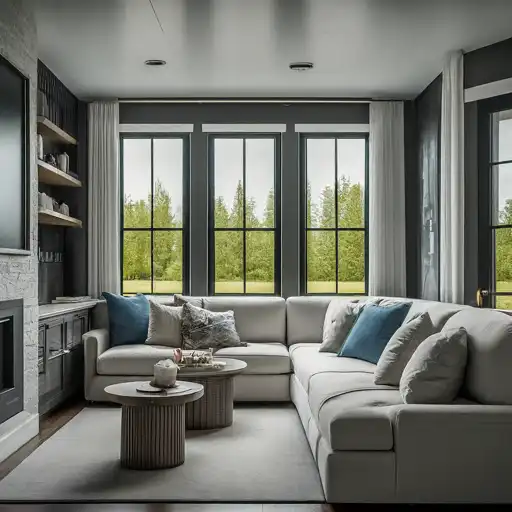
[88,102,120,297]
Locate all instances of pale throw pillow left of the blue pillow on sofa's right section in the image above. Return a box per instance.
[318,299,359,354]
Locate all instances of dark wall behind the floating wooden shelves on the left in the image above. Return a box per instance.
[37,61,87,304]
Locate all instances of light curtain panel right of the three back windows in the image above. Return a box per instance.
[368,101,406,297]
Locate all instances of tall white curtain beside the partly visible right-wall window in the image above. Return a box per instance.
[440,51,464,304]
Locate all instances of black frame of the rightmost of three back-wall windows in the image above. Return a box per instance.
[299,132,370,297]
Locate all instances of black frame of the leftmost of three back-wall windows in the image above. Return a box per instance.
[119,132,191,296]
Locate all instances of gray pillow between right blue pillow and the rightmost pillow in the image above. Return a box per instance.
[375,313,435,386]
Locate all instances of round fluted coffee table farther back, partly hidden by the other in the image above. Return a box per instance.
[178,357,247,430]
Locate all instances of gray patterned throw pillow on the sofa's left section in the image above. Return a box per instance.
[181,302,247,350]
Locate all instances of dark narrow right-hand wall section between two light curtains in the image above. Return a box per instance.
[414,75,443,300]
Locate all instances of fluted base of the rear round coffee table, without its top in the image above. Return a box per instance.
[185,375,233,430]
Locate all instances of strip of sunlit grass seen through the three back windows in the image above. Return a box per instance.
[123,280,364,294]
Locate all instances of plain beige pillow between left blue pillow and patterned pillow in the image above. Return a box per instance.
[146,299,182,348]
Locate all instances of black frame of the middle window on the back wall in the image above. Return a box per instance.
[207,132,282,297]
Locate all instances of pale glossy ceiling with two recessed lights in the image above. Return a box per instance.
[36,0,512,98]
